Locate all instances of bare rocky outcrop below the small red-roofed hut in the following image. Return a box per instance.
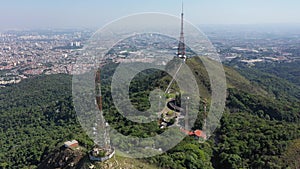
[38,146,85,169]
